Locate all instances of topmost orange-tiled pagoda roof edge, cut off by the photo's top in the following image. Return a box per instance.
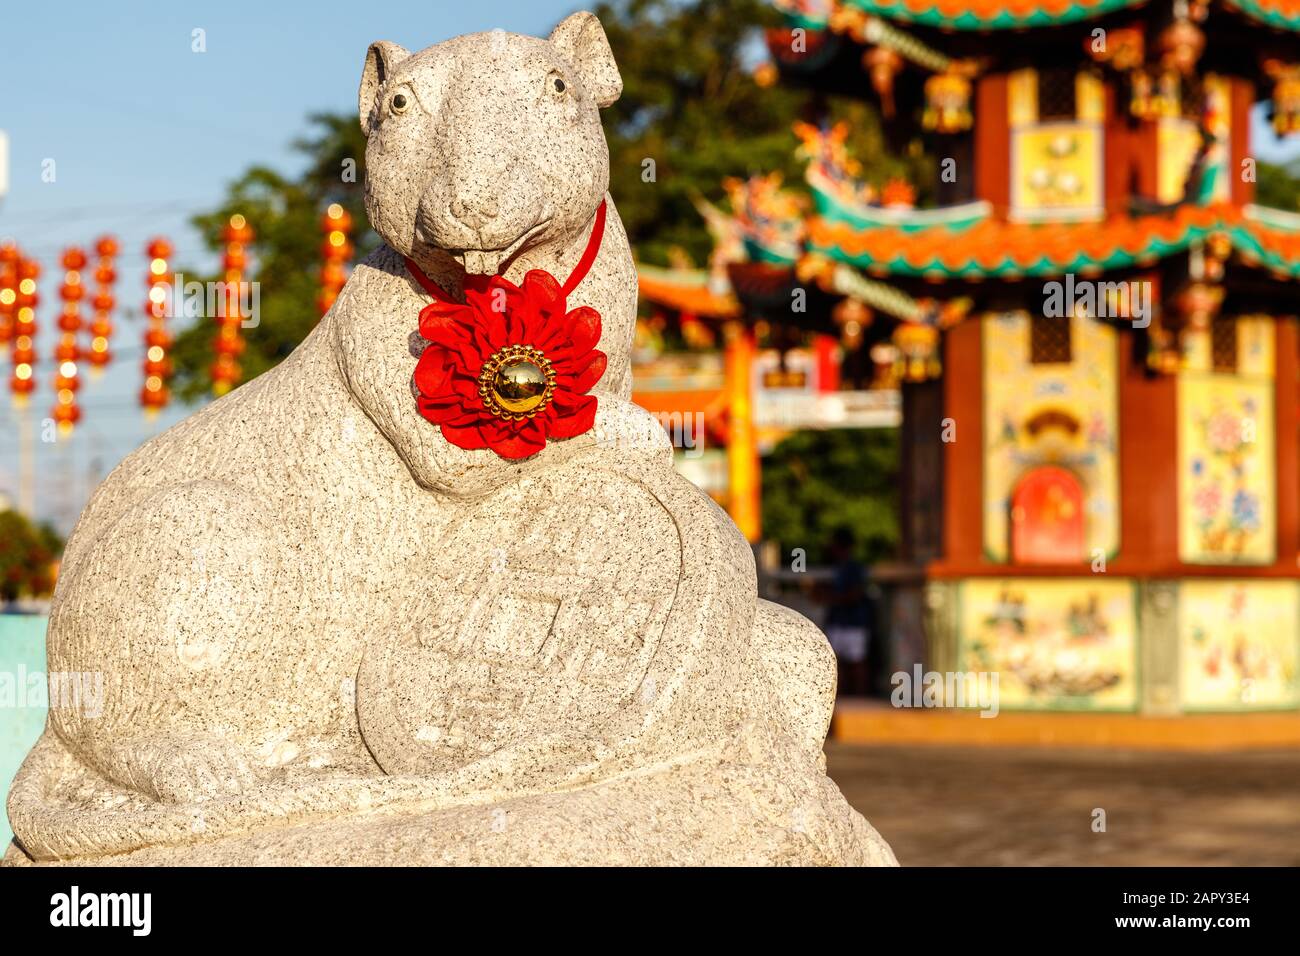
[774,0,1300,30]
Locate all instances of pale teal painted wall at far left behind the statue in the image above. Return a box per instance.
[0,614,48,852]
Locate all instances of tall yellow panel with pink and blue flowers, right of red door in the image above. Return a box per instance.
[1178,375,1277,564]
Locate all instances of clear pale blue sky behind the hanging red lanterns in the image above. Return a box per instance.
[0,0,581,525]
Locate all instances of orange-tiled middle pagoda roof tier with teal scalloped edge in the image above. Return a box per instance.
[807,204,1300,280]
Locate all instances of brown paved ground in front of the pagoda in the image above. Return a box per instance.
[827,741,1300,866]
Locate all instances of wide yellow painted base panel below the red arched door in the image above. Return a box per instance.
[958,578,1138,710]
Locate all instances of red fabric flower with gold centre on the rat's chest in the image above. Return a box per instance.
[415,269,606,459]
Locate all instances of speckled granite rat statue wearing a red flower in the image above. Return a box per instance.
[5,13,893,864]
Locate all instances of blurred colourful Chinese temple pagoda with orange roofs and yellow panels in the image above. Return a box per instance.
[636,0,1300,736]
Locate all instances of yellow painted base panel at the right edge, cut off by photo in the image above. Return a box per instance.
[1178,580,1300,710]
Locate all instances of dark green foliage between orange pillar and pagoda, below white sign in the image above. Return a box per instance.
[763,428,898,564]
